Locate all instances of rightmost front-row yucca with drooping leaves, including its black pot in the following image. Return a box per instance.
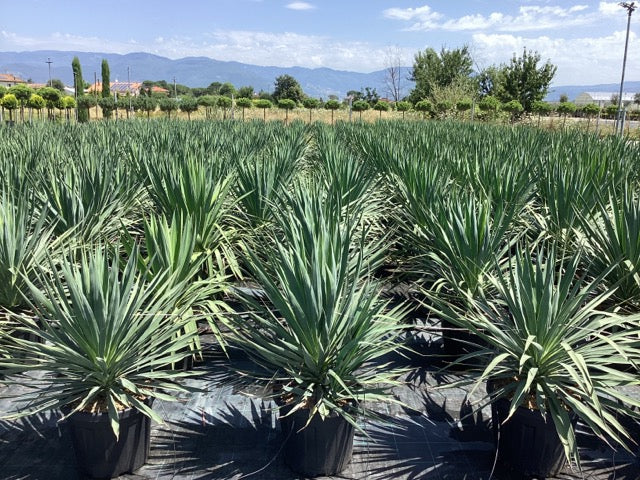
[432,247,640,477]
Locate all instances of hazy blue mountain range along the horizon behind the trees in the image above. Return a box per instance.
[0,50,640,101]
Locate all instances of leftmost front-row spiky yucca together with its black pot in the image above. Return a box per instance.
[0,245,198,478]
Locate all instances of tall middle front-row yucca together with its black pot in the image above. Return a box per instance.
[232,184,402,476]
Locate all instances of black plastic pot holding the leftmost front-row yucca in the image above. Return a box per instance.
[69,402,151,478]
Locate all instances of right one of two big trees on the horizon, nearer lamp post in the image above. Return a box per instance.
[496,48,557,112]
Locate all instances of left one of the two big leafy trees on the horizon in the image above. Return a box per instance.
[409,45,473,103]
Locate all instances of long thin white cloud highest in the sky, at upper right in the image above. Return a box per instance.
[383,5,596,32]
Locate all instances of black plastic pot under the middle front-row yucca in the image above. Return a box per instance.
[280,406,355,477]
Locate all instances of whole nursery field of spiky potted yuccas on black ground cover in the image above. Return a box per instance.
[0,119,640,480]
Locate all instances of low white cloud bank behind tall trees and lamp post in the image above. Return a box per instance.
[473,31,640,85]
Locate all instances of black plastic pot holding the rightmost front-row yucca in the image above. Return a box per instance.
[491,398,577,478]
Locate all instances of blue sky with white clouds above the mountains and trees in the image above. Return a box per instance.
[0,0,640,85]
